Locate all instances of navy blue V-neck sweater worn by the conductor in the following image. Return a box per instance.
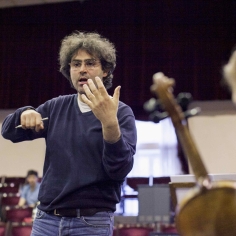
[2,94,137,211]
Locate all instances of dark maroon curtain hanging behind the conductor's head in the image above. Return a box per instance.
[0,0,236,120]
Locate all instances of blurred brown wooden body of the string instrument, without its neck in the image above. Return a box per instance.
[176,181,236,236]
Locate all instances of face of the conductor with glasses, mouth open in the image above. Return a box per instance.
[70,49,107,94]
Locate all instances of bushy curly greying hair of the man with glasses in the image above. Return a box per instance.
[59,31,116,89]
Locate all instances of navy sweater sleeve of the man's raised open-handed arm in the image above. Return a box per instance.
[103,103,137,181]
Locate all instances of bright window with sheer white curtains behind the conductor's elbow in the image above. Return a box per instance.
[128,118,182,177]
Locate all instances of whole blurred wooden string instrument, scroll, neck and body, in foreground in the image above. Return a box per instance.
[151,72,236,236]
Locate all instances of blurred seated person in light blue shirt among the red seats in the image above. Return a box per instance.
[18,170,40,208]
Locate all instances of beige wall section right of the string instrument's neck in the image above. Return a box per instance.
[188,101,236,173]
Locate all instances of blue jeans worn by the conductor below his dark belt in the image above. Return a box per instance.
[31,209,114,236]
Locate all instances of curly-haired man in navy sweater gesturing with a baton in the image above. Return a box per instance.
[2,32,137,236]
